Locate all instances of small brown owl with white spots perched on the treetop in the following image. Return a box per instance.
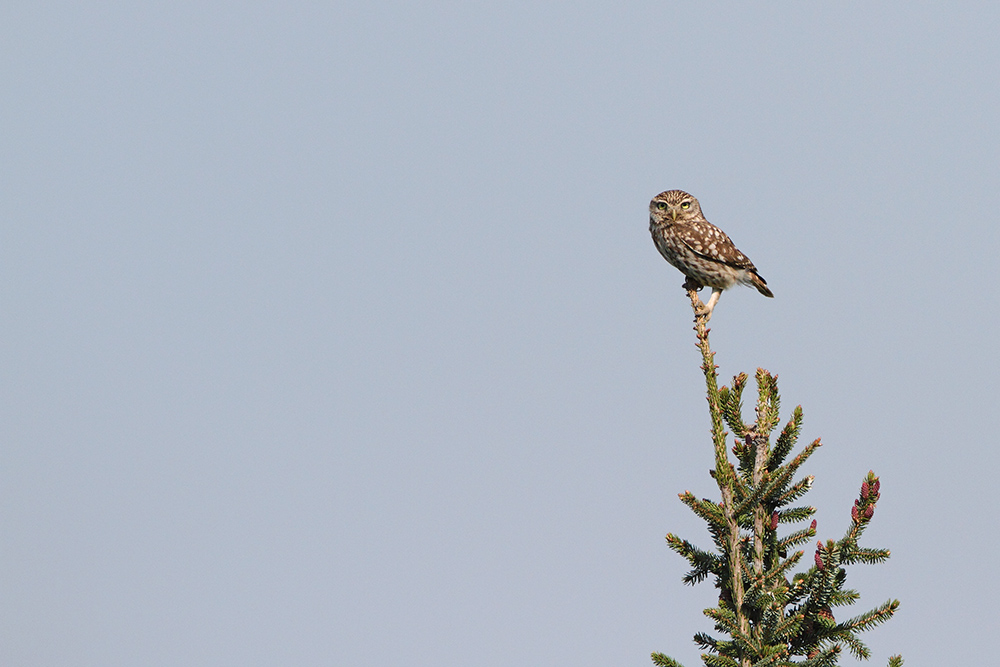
[649,190,774,319]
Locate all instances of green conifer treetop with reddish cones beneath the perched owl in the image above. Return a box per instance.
[652,289,903,667]
